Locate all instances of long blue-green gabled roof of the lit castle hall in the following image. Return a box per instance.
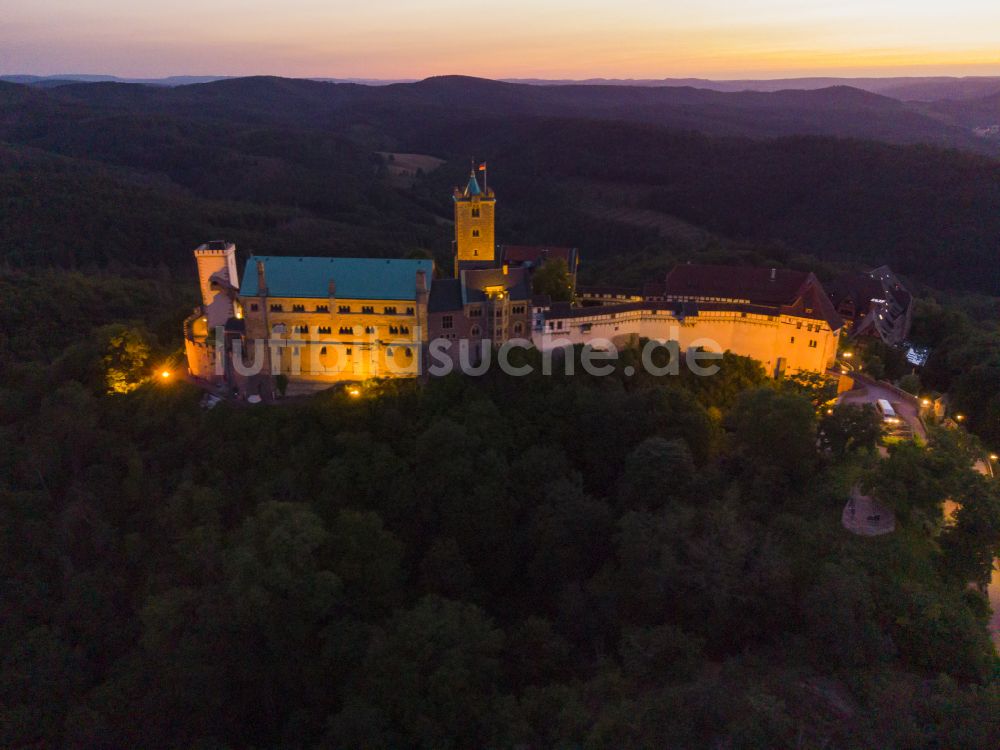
[240,255,434,300]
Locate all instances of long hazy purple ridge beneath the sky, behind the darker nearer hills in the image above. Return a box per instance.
[15,76,998,153]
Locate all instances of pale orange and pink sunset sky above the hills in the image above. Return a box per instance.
[0,0,1000,78]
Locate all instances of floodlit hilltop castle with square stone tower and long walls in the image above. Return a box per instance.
[184,168,844,397]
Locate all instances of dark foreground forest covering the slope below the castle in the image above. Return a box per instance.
[0,278,1000,748]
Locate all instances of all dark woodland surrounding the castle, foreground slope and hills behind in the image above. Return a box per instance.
[0,79,1000,750]
